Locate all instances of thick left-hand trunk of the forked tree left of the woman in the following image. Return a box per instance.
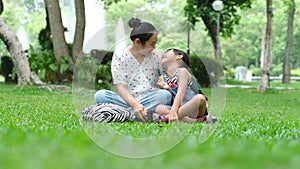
[45,0,71,82]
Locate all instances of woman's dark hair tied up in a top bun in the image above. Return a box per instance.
[128,17,157,45]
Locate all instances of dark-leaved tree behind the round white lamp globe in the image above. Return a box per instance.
[185,0,252,63]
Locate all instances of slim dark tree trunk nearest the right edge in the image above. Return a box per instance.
[282,0,295,84]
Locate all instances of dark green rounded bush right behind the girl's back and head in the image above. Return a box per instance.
[190,55,224,87]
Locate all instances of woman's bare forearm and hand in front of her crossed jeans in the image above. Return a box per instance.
[116,84,147,122]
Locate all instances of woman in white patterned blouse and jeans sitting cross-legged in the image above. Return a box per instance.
[95,18,172,122]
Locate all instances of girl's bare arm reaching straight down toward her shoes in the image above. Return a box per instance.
[169,68,191,121]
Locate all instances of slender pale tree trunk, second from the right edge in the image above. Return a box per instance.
[257,0,273,92]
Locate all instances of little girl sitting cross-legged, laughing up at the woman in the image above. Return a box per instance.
[155,49,212,123]
